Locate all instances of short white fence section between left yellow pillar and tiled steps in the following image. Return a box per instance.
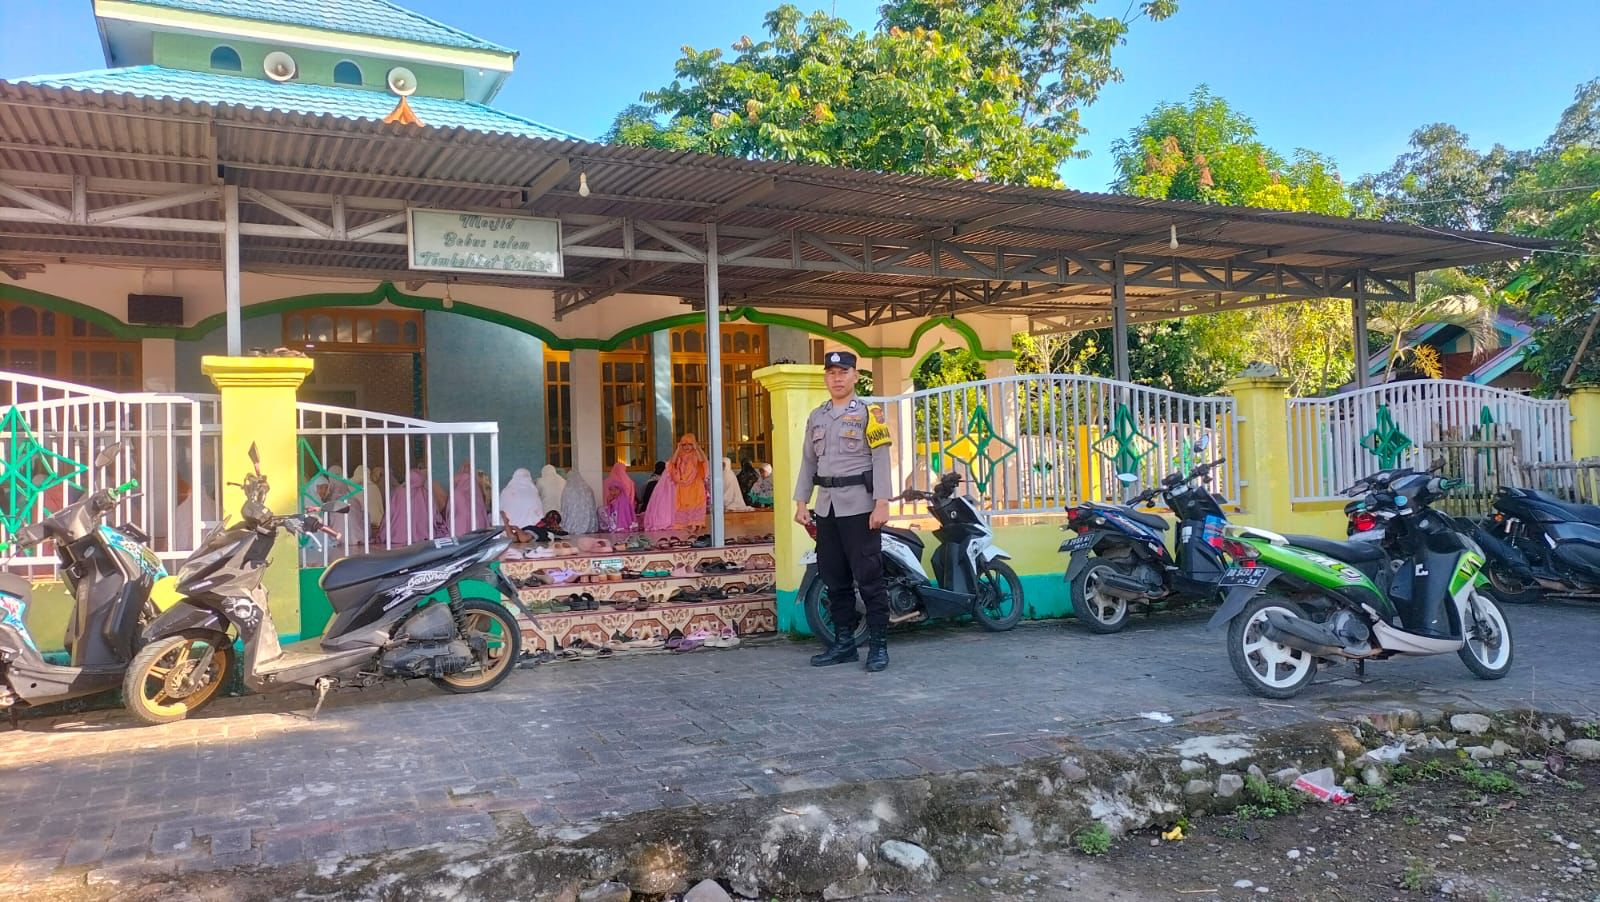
[296,401,499,566]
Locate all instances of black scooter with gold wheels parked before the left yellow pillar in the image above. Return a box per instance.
[123,446,522,723]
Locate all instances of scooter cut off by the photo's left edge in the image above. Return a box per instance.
[0,441,166,710]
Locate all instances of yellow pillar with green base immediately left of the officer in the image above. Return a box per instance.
[755,363,827,633]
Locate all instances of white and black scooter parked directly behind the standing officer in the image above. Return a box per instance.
[800,473,1022,645]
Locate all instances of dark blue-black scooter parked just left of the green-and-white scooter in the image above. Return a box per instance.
[1058,438,1227,633]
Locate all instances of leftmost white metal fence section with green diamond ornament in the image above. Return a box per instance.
[0,373,222,576]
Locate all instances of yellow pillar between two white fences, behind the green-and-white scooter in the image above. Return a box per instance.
[1222,376,1294,531]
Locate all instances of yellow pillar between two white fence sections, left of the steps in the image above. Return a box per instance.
[200,357,312,643]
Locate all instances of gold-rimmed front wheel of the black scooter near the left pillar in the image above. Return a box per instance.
[122,630,234,724]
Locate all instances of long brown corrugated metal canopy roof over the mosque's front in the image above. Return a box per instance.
[0,75,1550,324]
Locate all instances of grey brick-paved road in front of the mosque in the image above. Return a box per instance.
[0,605,1600,881]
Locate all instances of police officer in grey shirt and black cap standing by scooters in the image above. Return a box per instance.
[795,350,894,673]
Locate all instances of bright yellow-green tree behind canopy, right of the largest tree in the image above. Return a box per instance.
[1107,85,1354,393]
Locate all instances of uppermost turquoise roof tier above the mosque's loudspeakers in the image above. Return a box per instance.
[111,0,515,53]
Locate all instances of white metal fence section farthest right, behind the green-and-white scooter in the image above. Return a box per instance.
[1290,379,1573,501]
